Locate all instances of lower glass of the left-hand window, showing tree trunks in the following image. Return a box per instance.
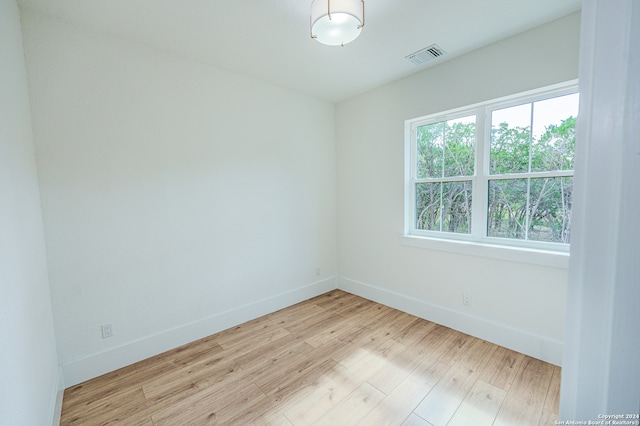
[416,181,471,234]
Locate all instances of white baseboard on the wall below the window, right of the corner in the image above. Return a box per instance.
[338,277,562,365]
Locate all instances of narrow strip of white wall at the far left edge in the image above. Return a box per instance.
[0,0,60,425]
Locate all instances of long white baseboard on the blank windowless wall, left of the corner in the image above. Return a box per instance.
[62,277,337,387]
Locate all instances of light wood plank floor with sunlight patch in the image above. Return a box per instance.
[61,290,560,426]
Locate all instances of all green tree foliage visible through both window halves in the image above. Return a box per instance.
[416,117,576,243]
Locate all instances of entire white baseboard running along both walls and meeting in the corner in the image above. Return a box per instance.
[60,277,562,392]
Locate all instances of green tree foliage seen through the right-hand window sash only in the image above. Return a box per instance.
[487,117,576,243]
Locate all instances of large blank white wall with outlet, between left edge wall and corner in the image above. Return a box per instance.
[23,10,337,385]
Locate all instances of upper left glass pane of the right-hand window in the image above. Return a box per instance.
[490,104,531,175]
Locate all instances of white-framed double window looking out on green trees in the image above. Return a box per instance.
[405,84,578,251]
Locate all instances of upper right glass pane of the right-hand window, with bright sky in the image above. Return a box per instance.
[531,93,579,171]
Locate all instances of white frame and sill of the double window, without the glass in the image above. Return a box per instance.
[401,80,578,268]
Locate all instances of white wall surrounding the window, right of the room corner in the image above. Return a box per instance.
[336,14,580,364]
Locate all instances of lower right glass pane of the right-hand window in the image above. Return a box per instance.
[528,177,573,243]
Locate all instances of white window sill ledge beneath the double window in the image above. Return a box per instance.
[400,235,569,269]
